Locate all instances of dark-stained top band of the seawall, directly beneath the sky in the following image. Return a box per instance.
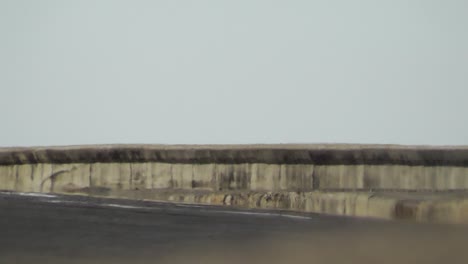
[0,144,468,166]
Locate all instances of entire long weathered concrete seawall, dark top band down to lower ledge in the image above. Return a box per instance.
[0,145,468,222]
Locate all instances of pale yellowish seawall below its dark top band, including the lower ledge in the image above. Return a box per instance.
[0,159,468,223]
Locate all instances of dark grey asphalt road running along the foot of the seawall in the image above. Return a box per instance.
[0,192,468,264]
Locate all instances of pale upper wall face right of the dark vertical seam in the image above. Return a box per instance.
[314,164,468,191]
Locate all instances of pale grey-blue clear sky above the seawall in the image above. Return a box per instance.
[0,0,468,146]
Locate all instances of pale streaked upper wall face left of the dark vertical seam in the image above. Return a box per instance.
[0,162,314,192]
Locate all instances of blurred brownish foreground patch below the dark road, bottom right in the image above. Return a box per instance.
[161,229,468,264]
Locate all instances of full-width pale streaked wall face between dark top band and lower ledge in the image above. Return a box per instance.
[0,162,468,192]
